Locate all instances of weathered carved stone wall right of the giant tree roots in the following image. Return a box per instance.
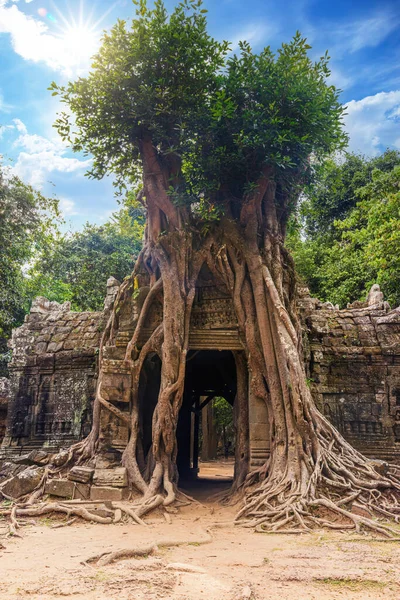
[305,298,400,463]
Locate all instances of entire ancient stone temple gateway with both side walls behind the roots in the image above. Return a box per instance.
[0,268,400,476]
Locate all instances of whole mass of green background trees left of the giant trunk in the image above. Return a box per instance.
[0,162,144,375]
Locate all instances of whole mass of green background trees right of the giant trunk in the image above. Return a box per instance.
[287,150,400,306]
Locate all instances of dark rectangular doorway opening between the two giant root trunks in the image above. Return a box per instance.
[177,350,237,491]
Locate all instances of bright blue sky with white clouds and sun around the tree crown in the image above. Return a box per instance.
[0,0,400,230]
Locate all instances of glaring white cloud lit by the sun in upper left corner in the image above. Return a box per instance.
[0,0,99,76]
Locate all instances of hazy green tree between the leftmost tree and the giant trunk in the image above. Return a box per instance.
[27,205,144,311]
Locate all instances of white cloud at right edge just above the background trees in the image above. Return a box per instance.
[344,90,400,156]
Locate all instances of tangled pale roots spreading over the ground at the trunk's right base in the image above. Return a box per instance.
[235,432,400,541]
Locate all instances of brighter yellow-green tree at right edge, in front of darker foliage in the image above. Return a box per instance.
[312,165,400,306]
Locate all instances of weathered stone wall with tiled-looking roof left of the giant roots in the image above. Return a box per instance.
[0,279,119,457]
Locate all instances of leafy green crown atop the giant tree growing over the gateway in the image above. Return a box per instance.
[50,0,346,225]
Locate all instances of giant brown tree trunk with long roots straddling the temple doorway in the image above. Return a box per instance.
[61,145,400,536]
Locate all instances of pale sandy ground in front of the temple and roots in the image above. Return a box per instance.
[0,462,400,600]
